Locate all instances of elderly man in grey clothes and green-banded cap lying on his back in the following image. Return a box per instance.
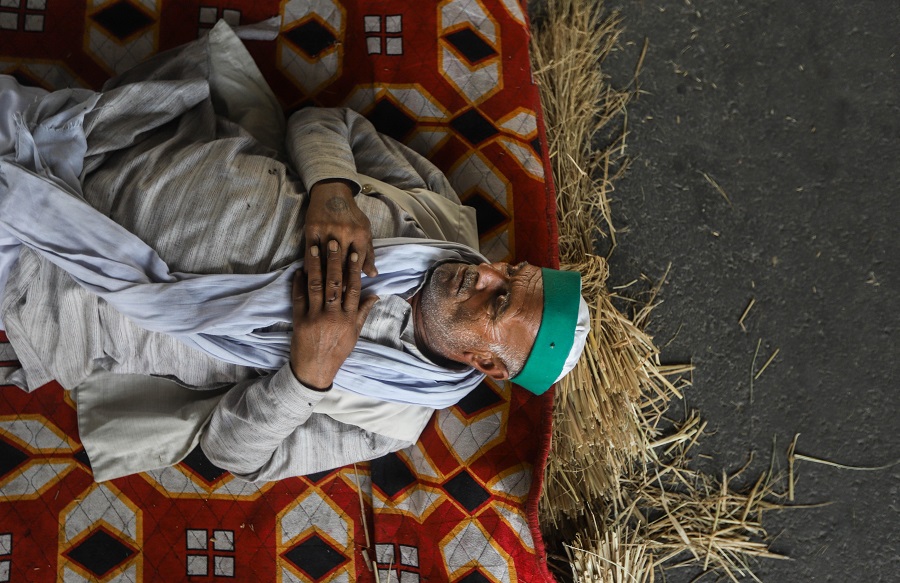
[0,24,587,480]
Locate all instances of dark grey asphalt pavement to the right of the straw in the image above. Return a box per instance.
[536,0,900,583]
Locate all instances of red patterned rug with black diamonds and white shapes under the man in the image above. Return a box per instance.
[0,0,556,583]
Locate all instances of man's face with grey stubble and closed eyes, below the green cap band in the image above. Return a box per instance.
[416,263,544,379]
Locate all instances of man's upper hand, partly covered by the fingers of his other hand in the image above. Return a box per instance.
[305,180,378,277]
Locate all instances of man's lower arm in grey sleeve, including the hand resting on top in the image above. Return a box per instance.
[201,239,380,477]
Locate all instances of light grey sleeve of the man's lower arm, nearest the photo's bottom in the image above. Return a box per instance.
[200,365,413,482]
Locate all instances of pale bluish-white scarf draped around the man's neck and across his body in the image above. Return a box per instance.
[0,78,484,408]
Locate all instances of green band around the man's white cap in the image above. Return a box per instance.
[512,267,581,395]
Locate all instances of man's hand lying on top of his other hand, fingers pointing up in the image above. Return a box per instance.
[291,239,378,390]
